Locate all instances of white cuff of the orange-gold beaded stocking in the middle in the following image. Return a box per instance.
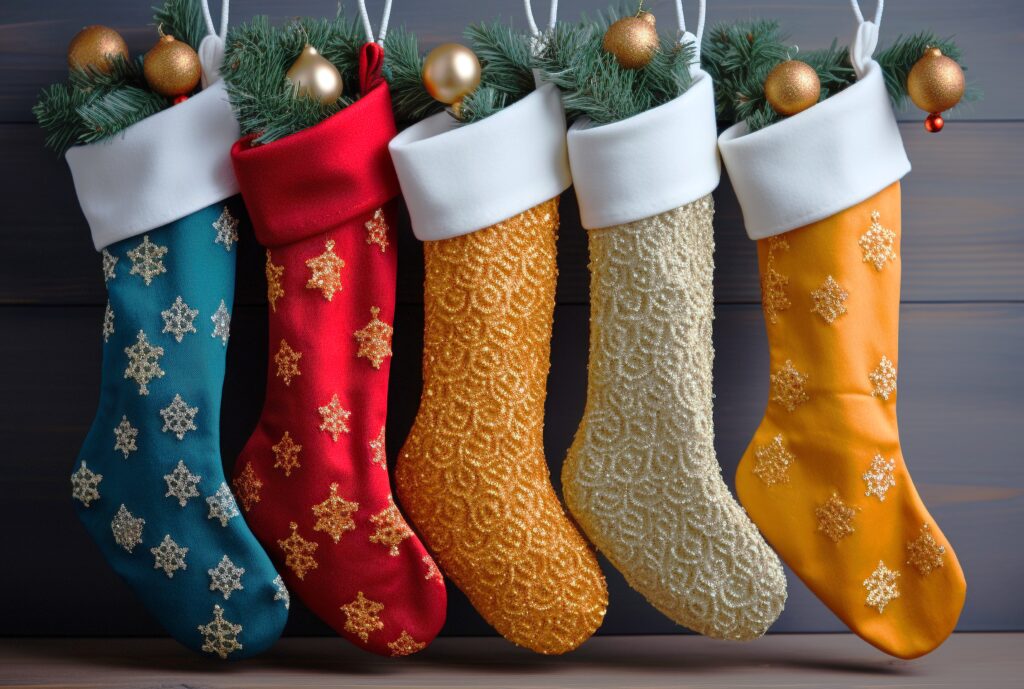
[388,84,572,242]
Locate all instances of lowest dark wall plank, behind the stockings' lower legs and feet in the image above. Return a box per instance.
[0,304,1024,636]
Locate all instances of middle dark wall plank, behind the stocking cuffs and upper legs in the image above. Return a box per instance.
[0,123,1024,304]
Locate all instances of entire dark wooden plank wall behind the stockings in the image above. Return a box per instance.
[0,0,1024,635]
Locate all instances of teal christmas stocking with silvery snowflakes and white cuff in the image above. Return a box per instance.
[68,39,288,658]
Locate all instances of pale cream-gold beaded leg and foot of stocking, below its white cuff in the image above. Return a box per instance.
[562,196,786,640]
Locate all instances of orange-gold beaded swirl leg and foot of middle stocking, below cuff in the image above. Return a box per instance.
[395,199,607,653]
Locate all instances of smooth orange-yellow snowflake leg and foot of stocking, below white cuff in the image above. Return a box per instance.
[736,182,966,658]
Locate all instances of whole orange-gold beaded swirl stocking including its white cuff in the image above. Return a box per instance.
[391,86,607,653]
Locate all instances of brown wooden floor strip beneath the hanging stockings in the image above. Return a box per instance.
[0,634,1024,689]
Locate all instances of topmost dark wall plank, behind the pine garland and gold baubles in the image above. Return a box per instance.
[0,0,1024,120]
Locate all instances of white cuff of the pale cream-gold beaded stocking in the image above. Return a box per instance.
[568,72,721,229]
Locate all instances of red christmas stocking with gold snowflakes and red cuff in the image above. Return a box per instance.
[231,44,446,655]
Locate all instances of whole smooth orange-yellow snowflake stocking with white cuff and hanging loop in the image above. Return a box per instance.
[720,18,965,658]
